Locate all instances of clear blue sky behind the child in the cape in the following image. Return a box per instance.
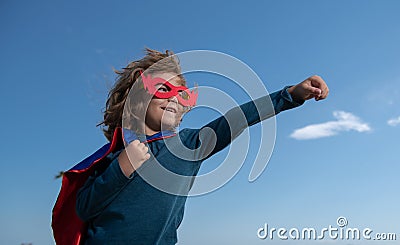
[0,0,400,244]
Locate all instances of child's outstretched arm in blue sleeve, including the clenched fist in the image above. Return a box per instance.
[191,76,329,159]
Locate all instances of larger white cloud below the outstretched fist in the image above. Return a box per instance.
[290,111,371,140]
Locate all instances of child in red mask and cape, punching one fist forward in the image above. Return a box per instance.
[53,49,328,244]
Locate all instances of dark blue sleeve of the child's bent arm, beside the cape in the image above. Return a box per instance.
[76,154,130,221]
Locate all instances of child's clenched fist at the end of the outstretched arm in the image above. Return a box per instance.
[288,76,329,101]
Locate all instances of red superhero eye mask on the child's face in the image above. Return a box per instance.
[140,72,199,106]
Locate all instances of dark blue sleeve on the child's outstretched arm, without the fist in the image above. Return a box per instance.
[192,87,304,159]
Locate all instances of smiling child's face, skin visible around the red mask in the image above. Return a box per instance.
[145,73,184,134]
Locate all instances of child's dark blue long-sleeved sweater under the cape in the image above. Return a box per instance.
[76,88,302,245]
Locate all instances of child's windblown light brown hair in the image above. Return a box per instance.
[97,48,186,141]
